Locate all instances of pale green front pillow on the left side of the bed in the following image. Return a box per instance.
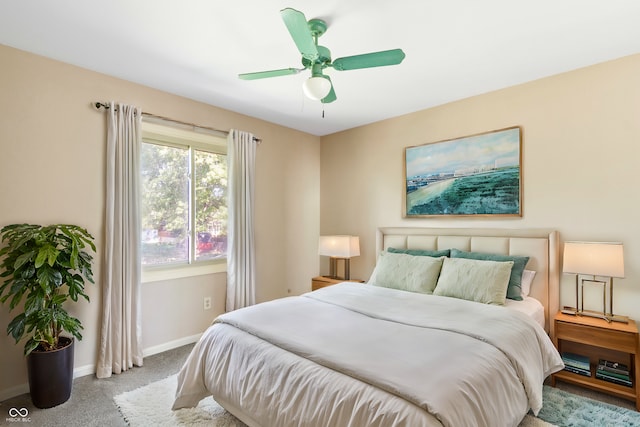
[369,251,444,294]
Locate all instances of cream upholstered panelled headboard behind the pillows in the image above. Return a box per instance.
[376,227,560,332]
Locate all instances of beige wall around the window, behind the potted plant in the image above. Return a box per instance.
[0,45,320,400]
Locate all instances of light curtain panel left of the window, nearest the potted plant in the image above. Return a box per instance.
[96,102,142,378]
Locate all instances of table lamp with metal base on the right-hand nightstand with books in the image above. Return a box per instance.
[562,242,629,323]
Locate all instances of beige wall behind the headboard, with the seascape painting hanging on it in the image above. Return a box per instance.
[320,55,640,319]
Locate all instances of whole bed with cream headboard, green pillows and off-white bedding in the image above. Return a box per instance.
[173,227,563,427]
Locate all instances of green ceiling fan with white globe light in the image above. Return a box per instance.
[238,8,405,104]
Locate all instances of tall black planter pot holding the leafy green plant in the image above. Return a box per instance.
[27,337,74,409]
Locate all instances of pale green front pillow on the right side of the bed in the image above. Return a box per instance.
[433,258,513,305]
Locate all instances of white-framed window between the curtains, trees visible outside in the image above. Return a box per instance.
[140,122,227,278]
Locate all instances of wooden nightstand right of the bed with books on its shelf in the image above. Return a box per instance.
[551,313,640,410]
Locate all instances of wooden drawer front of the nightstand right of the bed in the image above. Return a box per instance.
[555,322,638,354]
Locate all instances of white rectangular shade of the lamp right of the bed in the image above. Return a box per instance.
[562,242,624,278]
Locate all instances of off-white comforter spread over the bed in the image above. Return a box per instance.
[173,283,563,427]
